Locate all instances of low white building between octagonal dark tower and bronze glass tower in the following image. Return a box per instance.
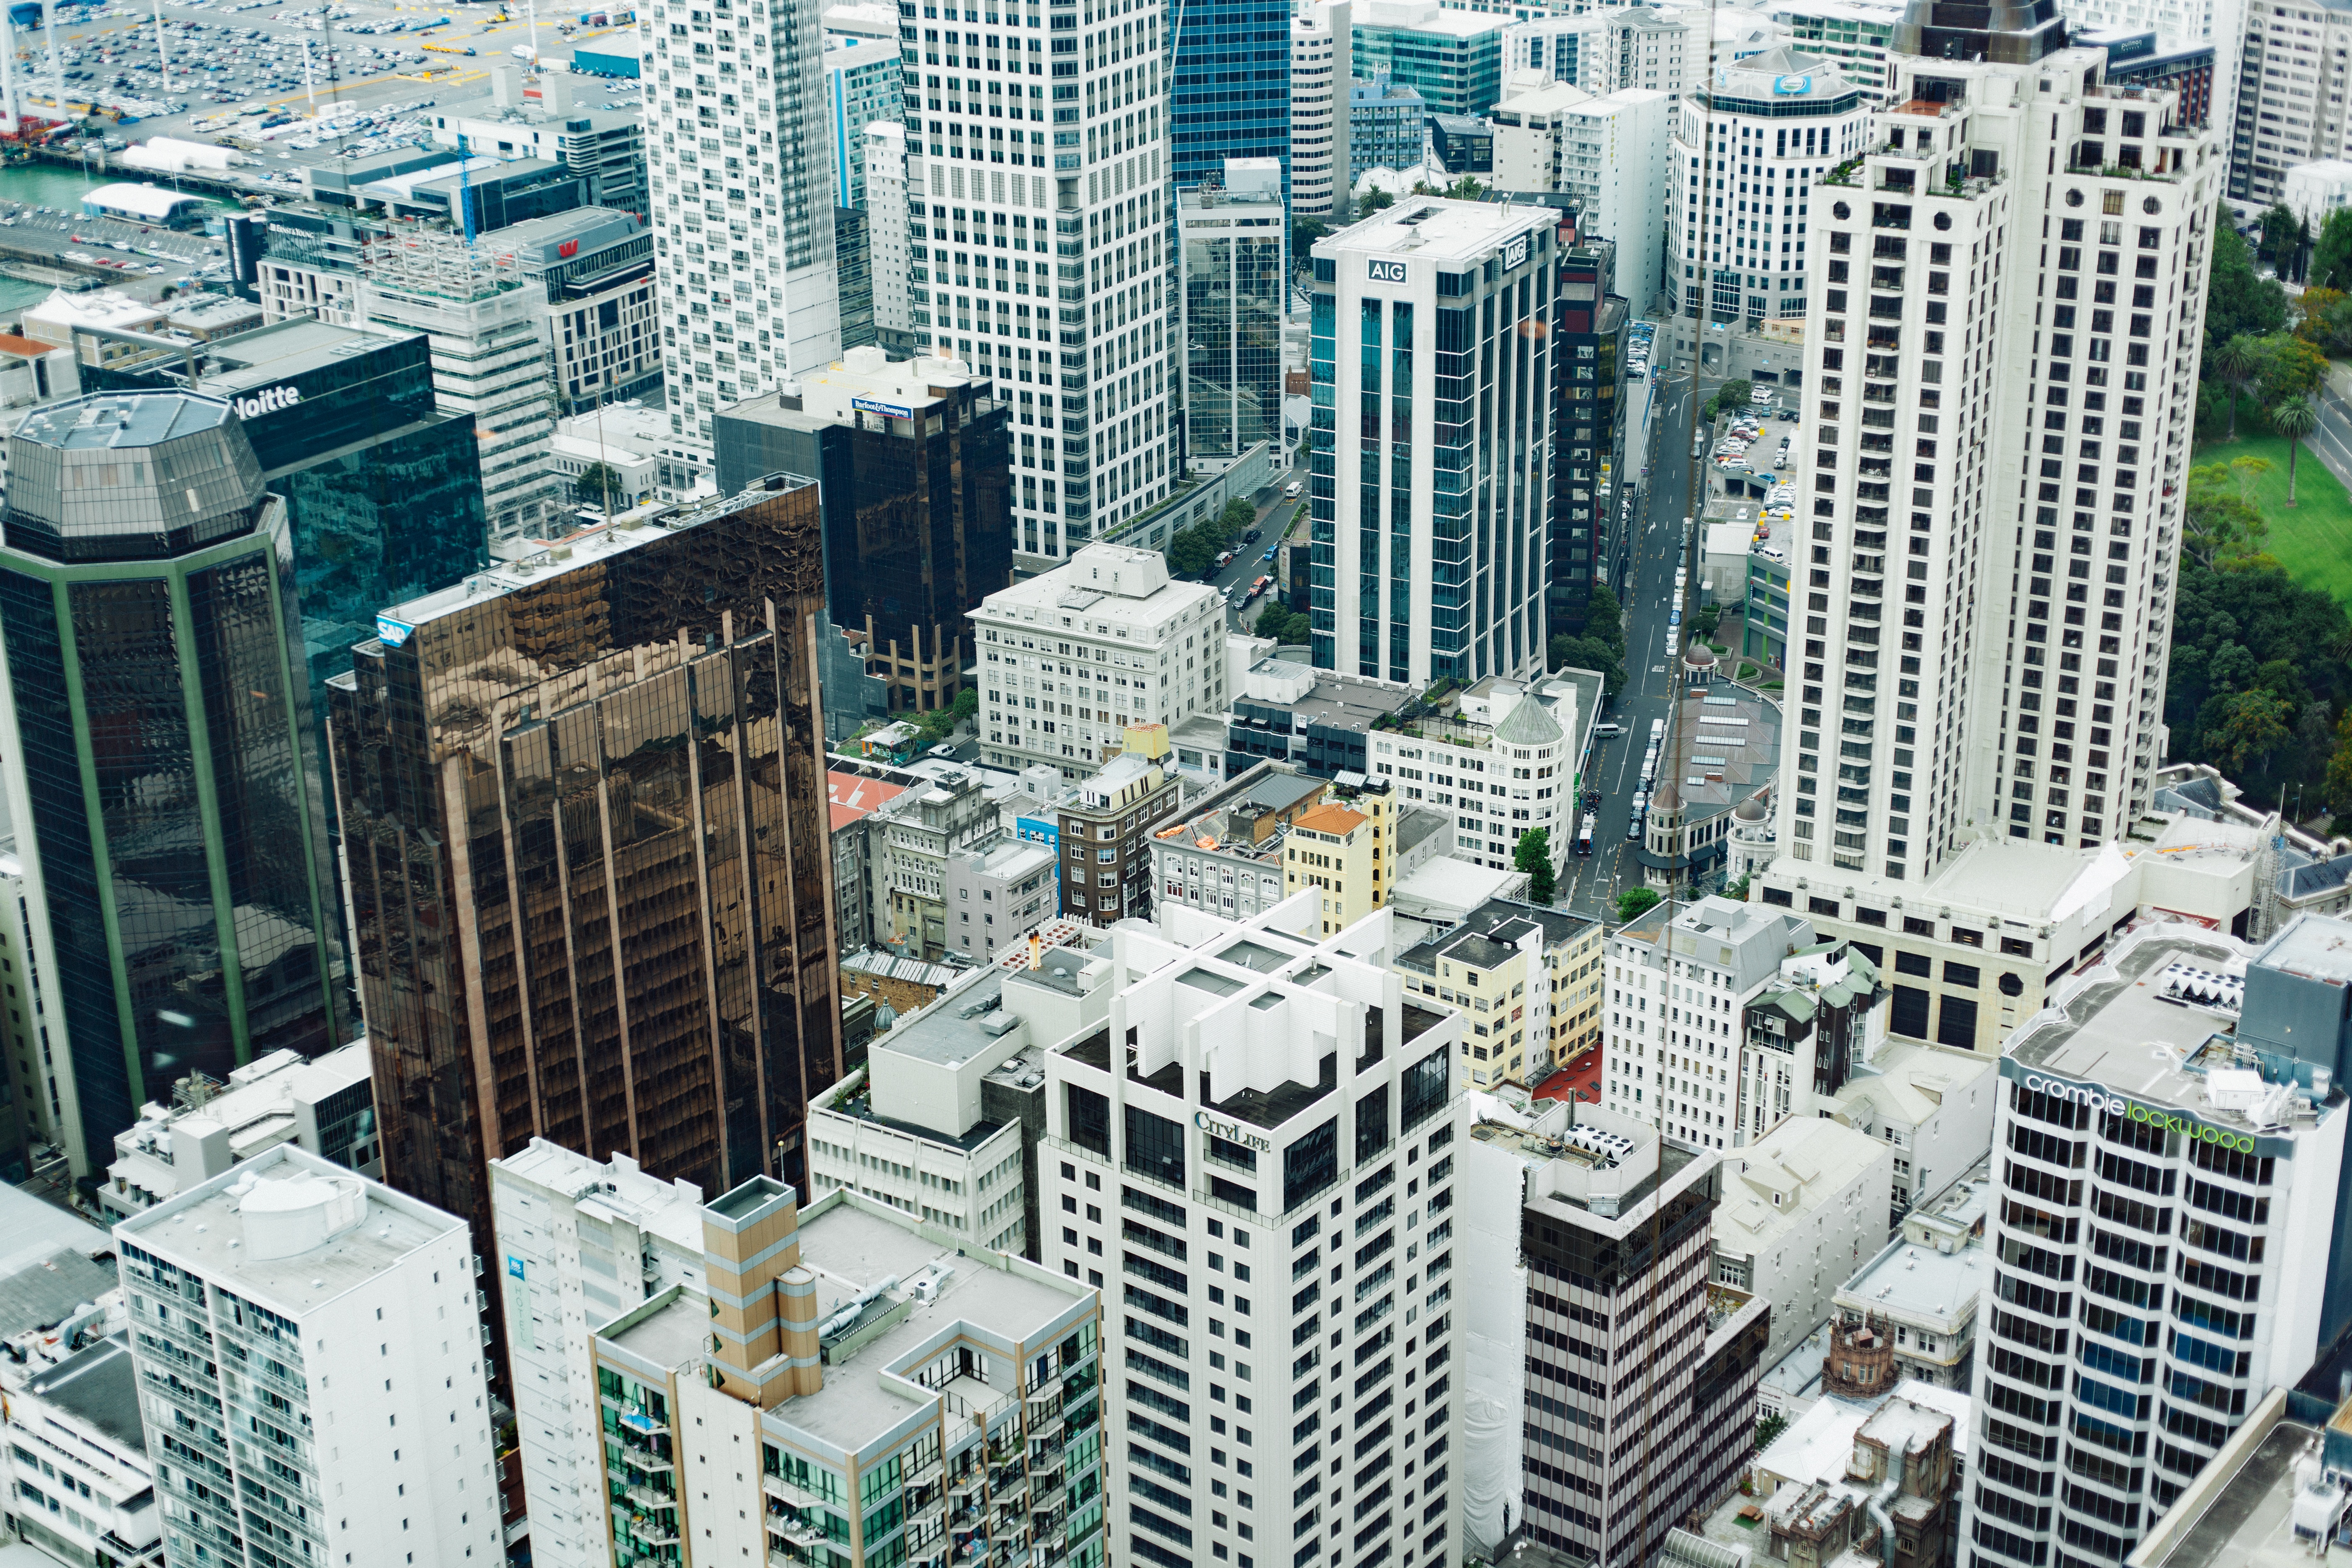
[96,1039,383,1220]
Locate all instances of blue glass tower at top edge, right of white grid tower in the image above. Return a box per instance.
[1169,0,1291,204]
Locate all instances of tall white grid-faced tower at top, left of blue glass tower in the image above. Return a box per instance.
[901,0,1183,571]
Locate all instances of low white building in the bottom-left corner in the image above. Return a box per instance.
[0,1333,165,1568]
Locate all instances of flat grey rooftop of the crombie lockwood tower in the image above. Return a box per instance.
[2004,926,2343,1138]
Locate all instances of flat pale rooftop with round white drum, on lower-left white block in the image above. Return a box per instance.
[115,1145,466,1321]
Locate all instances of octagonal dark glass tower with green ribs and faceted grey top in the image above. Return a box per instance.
[0,392,343,1173]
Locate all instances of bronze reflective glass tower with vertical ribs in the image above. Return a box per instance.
[329,477,842,1255]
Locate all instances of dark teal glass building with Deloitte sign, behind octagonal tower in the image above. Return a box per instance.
[85,320,489,747]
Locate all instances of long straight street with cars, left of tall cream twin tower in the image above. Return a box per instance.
[1555,369,1712,921]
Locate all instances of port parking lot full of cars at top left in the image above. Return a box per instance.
[16,0,637,191]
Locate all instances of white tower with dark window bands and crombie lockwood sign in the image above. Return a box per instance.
[1969,915,2352,1568]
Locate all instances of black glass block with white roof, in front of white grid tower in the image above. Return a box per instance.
[710,348,1014,712]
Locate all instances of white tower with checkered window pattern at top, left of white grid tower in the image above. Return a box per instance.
[637,0,842,447]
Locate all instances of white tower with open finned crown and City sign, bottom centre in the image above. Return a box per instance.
[1037,893,1475,1568]
